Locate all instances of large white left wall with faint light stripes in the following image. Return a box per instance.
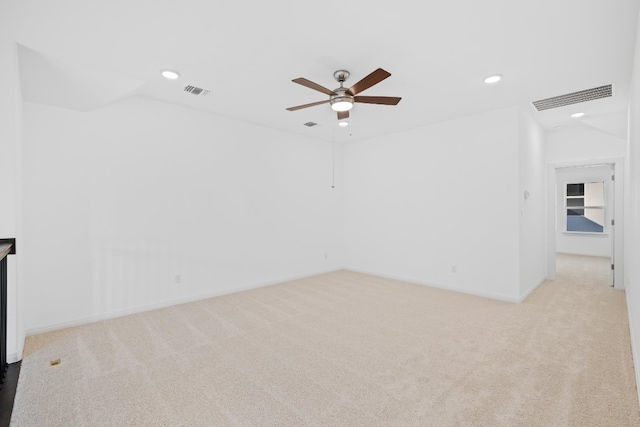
[22,98,342,332]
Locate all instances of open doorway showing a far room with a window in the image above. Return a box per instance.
[547,159,624,289]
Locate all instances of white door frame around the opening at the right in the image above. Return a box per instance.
[547,157,625,289]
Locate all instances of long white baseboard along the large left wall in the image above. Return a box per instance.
[23,267,343,338]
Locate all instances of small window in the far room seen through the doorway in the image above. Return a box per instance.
[564,182,604,233]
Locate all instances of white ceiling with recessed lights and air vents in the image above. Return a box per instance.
[2,0,640,141]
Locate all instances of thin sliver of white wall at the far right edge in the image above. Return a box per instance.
[624,7,640,412]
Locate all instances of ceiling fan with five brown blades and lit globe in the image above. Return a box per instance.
[287,68,402,120]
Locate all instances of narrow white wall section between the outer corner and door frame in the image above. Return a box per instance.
[518,111,547,299]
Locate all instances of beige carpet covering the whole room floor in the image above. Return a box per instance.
[11,256,640,427]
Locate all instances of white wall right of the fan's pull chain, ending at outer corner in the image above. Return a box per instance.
[344,108,524,301]
